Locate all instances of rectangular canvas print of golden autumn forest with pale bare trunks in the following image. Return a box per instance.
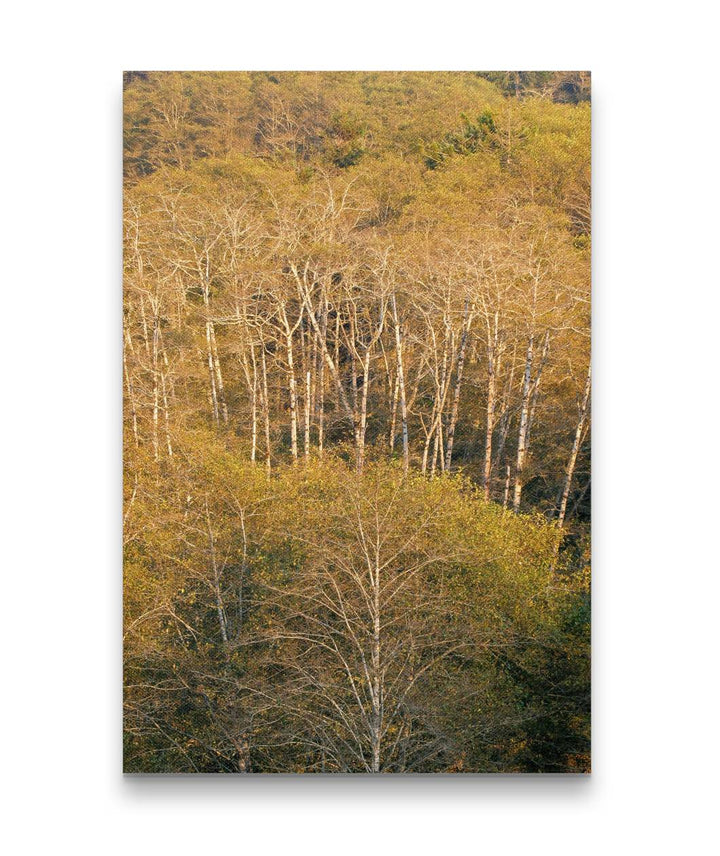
[122,71,591,774]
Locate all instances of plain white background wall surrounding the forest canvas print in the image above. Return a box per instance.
[0,0,720,854]
